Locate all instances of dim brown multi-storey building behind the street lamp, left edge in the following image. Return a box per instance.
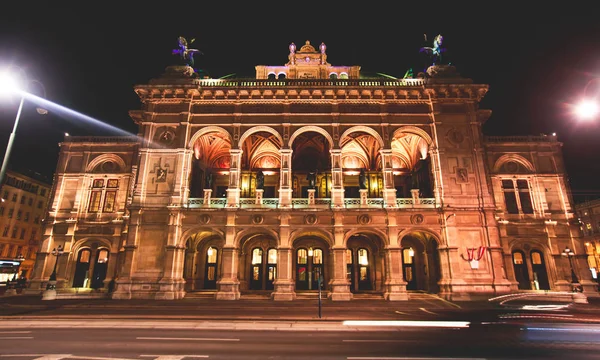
[0,170,51,283]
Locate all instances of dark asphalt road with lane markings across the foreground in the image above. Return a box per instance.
[0,324,600,360]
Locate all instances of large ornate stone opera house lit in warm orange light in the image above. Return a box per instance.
[30,41,596,300]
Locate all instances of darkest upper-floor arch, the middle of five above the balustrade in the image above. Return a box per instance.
[292,131,331,198]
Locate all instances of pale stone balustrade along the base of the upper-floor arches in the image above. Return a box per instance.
[187,198,436,209]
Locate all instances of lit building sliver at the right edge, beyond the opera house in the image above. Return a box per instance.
[575,200,600,281]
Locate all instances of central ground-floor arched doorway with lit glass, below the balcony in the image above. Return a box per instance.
[294,238,329,291]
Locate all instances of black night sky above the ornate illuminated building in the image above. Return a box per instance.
[0,1,600,200]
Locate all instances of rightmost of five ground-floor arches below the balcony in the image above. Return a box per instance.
[401,231,441,294]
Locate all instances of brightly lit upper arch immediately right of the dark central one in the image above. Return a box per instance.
[340,131,383,199]
